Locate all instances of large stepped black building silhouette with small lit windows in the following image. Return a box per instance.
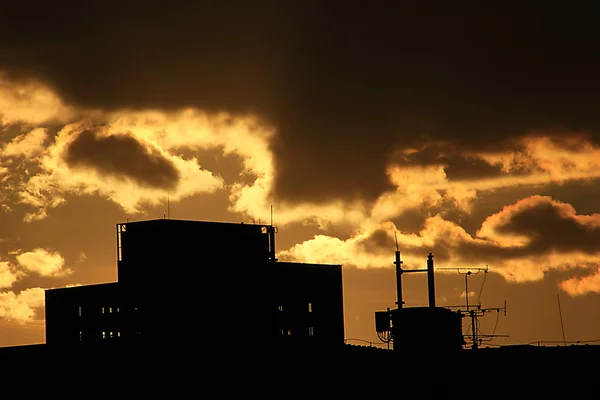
[46,219,344,350]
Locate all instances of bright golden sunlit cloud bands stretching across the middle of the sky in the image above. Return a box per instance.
[0,75,600,294]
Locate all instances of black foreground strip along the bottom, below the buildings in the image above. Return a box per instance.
[0,345,600,399]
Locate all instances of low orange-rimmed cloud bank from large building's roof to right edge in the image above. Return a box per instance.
[279,196,600,294]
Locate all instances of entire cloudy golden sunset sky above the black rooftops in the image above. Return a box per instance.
[0,0,600,345]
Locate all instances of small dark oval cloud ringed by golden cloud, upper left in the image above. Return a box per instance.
[64,130,179,190]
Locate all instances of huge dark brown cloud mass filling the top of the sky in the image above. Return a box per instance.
[0,1,600,201]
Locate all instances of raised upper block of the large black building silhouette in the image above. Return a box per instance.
[117,219,275,286]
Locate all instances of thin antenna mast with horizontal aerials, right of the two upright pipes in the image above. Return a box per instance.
[438,265,508,350]
